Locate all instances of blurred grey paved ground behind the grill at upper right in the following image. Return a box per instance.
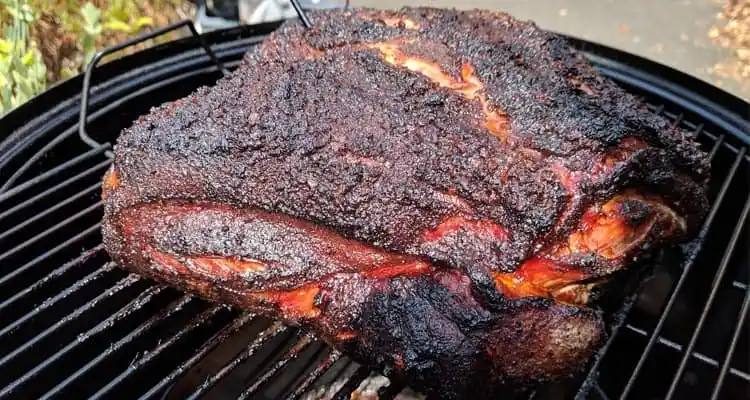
[351,0,750,100]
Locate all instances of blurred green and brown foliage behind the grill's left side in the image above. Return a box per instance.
[0,0,190,116]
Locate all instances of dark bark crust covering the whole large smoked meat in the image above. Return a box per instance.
[104,8,709,398]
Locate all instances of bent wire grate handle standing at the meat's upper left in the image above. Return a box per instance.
[78,19,229,158]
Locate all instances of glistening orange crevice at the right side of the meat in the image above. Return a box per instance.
[494,190,687,304]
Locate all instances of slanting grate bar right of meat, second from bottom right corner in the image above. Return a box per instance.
[665,196,750,400]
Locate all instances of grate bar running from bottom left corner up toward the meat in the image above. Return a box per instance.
[4,286,166,393]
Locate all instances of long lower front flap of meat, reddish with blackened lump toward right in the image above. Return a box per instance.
[103,201,604,398]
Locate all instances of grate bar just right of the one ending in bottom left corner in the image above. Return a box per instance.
[40,295,195,400]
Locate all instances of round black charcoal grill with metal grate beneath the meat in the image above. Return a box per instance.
[0,19,750,399]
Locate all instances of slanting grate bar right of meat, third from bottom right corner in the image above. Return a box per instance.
[620,148,746,400]
